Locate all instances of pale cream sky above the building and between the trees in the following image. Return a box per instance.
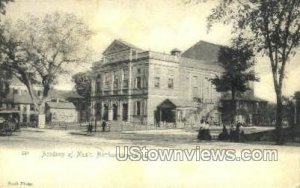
[6,0,300,101]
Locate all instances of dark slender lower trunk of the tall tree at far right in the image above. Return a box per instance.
[275,91,284,145]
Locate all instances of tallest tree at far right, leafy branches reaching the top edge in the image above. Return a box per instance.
[208,0,300,144]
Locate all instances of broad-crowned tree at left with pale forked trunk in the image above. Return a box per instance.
[0,12,92,126]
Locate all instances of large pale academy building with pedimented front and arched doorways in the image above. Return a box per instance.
[92,40,223,124]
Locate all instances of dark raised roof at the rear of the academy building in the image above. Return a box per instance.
[182,41,222,64]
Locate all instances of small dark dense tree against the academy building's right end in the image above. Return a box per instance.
[211,38,258,121]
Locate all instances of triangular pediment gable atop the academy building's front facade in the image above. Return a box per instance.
[103,39,143,55]
